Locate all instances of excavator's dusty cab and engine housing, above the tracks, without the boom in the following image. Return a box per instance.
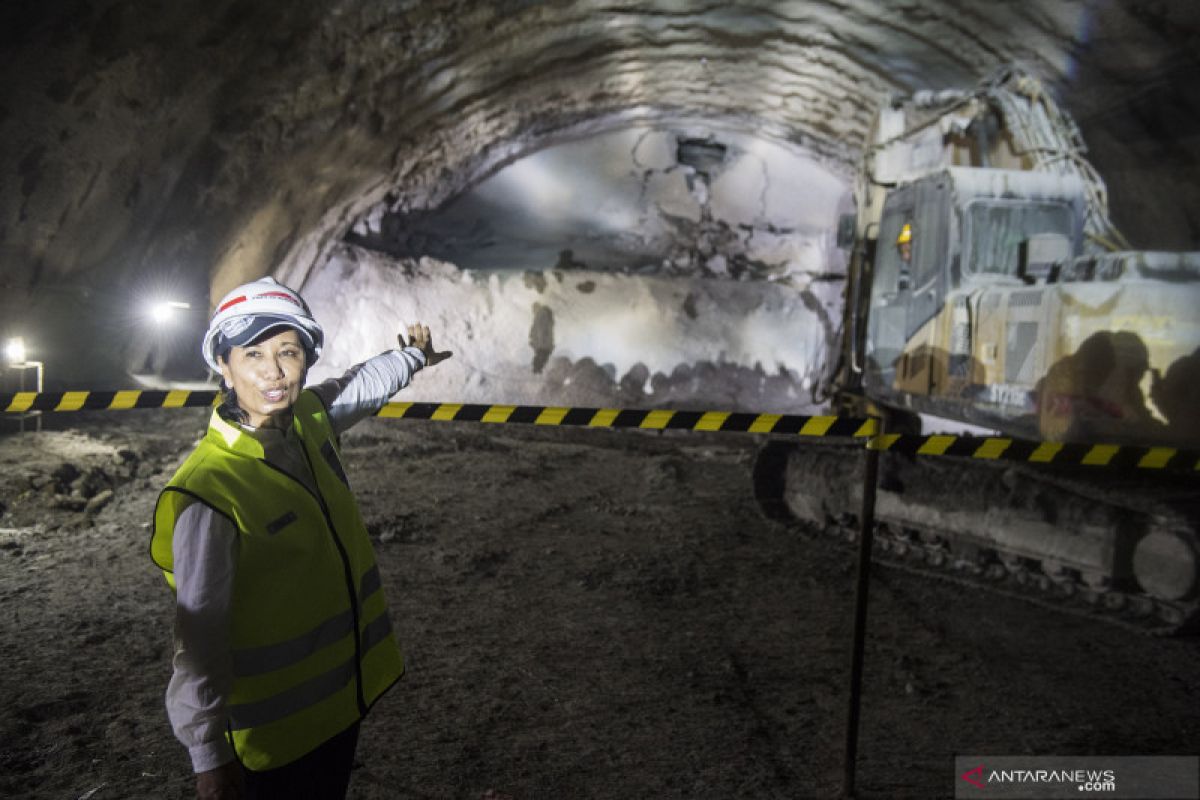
[863,167,1200,446]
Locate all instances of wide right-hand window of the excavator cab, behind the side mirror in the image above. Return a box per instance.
[965,199,1074,278]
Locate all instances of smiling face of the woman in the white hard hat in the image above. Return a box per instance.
[220,329,308,428]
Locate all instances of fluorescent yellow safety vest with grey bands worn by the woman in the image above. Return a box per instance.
[150,391,404,770]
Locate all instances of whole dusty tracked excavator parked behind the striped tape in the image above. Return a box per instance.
[755,67,1200,633]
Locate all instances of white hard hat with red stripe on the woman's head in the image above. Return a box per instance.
[202,277,325,373]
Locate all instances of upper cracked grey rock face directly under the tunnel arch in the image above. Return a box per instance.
[348,121,853,279]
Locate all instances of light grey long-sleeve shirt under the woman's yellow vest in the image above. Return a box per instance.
[167,347,425,772]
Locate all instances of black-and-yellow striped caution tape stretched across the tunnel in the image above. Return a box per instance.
[0,390,1200,473]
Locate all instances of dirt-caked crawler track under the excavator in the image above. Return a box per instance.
[755,440,1200,636]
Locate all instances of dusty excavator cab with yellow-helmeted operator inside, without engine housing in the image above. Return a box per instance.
[864,168,1099,426]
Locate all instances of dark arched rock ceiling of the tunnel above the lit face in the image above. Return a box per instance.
[0,0,1200,317]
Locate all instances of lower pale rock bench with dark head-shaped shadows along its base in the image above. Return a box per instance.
[304,246,840,411]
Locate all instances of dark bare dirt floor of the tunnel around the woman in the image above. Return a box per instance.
[0,410,1200,800]
